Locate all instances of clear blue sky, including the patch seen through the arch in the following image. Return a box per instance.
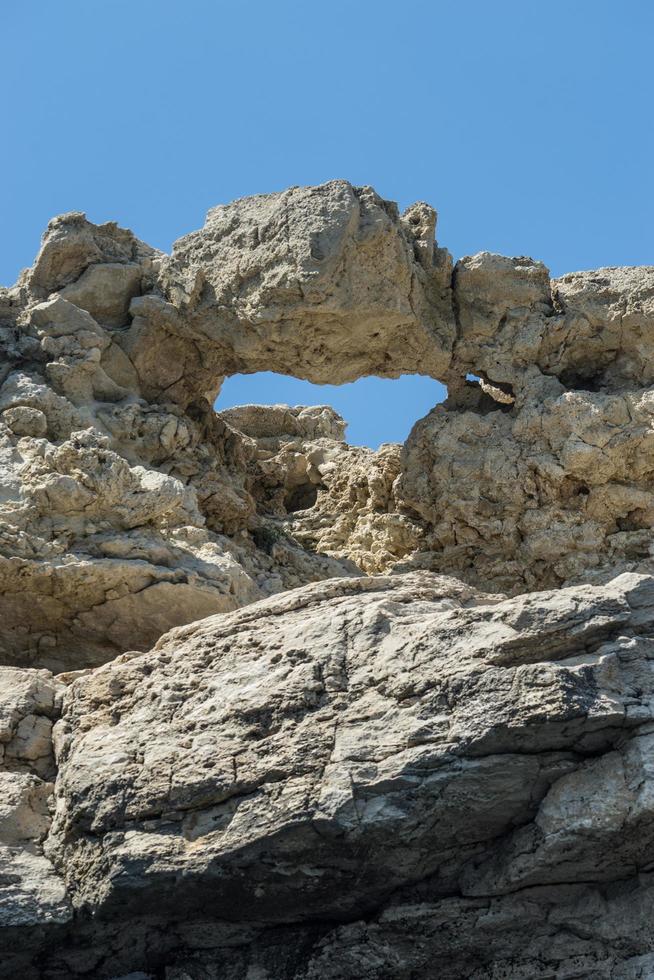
[0,0,654,444]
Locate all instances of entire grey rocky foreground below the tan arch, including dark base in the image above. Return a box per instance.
[5,573,654,980]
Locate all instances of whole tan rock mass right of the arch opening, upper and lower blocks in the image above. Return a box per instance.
[398,254,654,592]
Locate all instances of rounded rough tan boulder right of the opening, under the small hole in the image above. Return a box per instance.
[396,385,654,591]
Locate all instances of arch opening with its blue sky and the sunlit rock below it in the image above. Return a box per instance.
[215,372,454,588]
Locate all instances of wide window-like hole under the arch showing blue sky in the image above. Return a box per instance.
[214,371,447,450]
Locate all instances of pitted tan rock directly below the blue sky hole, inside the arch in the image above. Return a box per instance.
[218,405,422,572]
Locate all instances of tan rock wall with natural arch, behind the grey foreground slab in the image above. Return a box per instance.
[0,181,654,668]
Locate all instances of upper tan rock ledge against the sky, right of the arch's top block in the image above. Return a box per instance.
[454,252,654,391]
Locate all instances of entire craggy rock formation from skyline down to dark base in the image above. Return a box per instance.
[0,181,654,980]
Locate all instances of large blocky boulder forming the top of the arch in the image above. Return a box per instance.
[161,181,455,384]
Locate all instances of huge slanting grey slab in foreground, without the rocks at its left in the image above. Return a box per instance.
[49,575,654,921]
